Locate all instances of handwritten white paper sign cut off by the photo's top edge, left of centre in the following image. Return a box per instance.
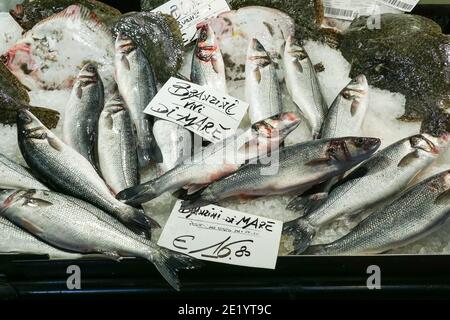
[152,0,231,45]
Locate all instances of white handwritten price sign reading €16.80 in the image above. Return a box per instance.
[158,201,283,269]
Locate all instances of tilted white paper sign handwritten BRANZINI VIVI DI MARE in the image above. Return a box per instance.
[144,77,249,142]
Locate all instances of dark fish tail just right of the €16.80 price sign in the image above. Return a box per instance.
[283,219,316,255]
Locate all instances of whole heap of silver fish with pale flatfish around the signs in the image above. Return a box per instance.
[0,0,450,288]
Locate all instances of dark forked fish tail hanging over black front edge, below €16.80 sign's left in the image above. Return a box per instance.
[151,248,202,291]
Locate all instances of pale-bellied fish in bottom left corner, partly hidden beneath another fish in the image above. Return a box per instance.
[0,214,81,259]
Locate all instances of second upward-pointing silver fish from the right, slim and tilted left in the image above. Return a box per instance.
[283,36,326,139]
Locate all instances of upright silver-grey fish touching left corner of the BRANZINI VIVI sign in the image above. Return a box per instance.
[114,33,162,168]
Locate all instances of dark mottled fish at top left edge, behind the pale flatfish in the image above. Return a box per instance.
[10,0,121,30]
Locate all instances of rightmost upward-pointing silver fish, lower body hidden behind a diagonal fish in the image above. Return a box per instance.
[320,75,369,139]
